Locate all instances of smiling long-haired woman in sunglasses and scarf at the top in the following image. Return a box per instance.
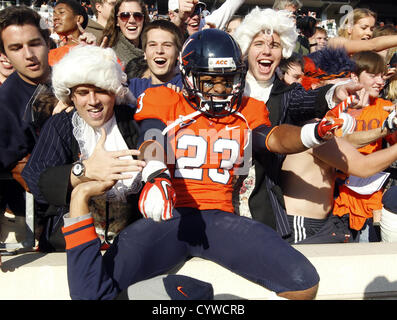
[101,0,149,78]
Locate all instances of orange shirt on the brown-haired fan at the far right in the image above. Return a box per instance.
[333,98,395,230]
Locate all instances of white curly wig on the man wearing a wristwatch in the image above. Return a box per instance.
[52,45,136,104]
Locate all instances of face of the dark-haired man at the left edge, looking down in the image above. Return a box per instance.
[1,24,50,85]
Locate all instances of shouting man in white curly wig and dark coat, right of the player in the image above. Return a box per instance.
[233,7,359,237]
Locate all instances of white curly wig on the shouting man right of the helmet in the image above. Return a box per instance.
[233,7,298,59]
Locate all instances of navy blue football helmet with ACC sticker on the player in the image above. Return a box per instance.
[179,29,247,117]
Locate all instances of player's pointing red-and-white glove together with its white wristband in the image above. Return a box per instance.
[301,96,356,148]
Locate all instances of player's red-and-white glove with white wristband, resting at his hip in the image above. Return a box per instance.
[138,161,176,222]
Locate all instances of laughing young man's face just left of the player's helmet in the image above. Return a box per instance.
[145,29,178,84]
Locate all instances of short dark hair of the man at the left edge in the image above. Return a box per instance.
[0,6,50,53]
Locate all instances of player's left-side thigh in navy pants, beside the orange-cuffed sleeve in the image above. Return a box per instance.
[104,215,188,290]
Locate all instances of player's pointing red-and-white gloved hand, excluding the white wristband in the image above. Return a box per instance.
[315,96,356,140]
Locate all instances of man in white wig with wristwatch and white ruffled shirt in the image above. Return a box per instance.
[23,46,144,251]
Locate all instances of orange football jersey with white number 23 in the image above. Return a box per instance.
[135,87,270,212]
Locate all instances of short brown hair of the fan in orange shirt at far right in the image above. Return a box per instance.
[352,51,387,76]
